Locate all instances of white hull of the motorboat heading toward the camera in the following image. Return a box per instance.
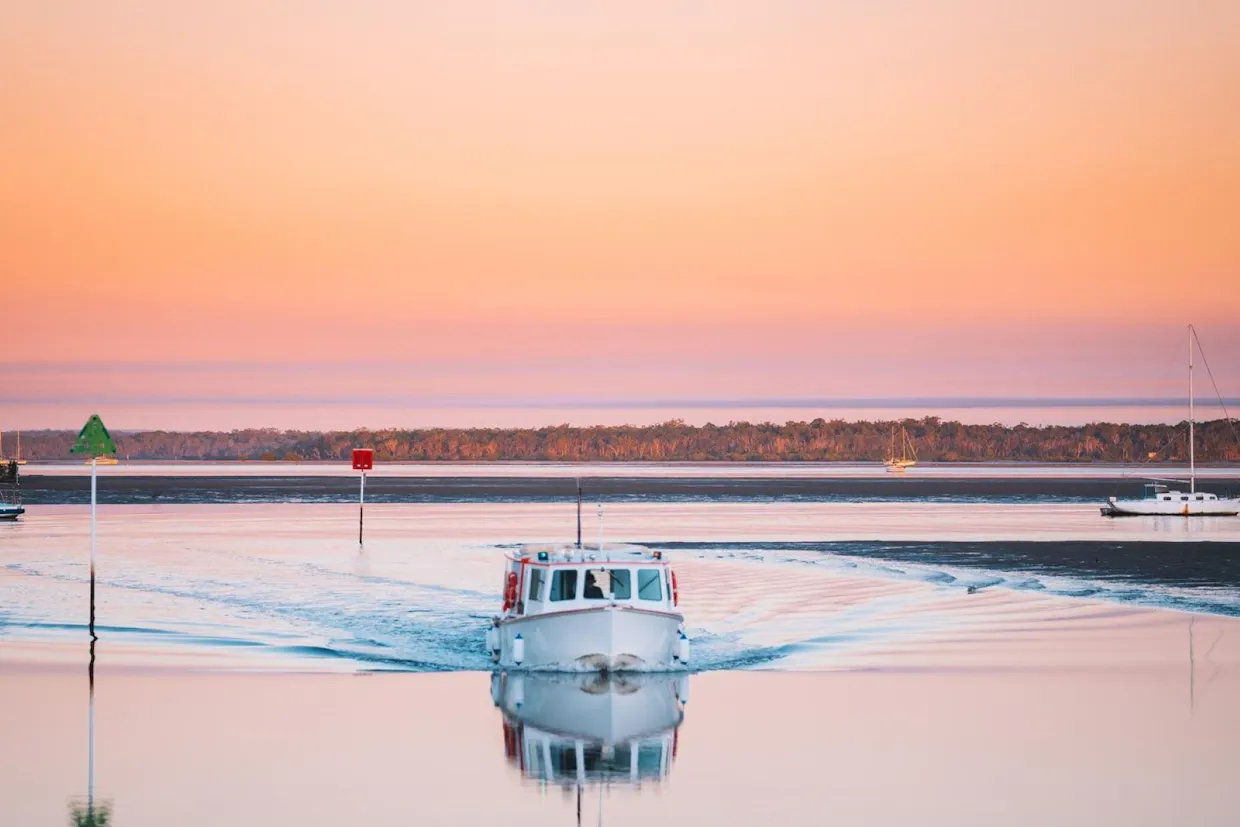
[496,605,684,672]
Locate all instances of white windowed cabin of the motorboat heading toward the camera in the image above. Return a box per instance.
[503,546,680,616]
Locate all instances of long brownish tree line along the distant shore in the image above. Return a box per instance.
[9,417,1240,462]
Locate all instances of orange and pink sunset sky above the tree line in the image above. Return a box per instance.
[0,0,1240,429]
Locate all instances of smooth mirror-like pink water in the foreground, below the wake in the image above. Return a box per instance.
[0,661,1240,827]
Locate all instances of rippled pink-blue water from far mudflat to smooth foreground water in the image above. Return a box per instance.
[0,503,1240,671]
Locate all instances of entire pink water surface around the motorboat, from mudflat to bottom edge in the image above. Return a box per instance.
[7,502,1240,827]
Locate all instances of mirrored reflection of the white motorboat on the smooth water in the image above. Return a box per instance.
[491,672,688,796]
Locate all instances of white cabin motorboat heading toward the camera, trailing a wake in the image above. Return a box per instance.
[486,543,689,672]
